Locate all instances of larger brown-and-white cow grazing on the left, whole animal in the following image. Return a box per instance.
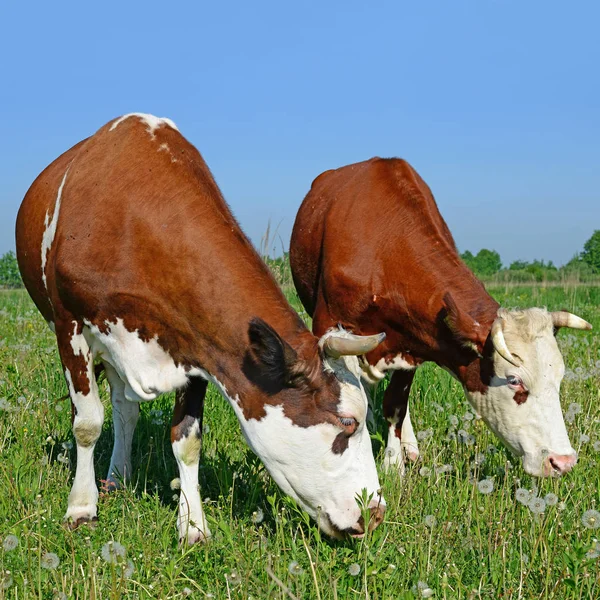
[16,113,385,543]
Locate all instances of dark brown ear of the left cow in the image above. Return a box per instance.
[244,317,308,394]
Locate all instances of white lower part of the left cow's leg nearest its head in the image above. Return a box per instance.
[173,421,211,544]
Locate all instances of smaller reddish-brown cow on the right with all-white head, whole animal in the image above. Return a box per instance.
[290,158,591,476]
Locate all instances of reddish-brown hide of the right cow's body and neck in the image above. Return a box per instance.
[290,158,498,389]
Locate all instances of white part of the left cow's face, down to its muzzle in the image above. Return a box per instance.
[211,356,385,536]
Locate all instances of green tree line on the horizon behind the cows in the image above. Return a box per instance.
[0,229,600,288]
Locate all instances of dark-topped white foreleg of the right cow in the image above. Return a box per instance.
[383,370,419,474]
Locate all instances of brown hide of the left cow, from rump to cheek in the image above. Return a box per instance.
[16,117,339,426]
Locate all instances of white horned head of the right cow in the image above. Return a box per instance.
[465,308,591,476]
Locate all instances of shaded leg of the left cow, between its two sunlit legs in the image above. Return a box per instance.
[104,364,140,490]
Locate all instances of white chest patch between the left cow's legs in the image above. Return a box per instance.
[84,318,193,402]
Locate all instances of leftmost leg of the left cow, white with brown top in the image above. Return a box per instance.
[56,319,104,527]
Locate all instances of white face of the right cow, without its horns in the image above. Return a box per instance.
[465,309,575,476]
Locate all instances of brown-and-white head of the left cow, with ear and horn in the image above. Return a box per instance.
[234,319,385,537]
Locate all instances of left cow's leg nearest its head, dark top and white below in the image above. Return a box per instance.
[171,377,210,544]
